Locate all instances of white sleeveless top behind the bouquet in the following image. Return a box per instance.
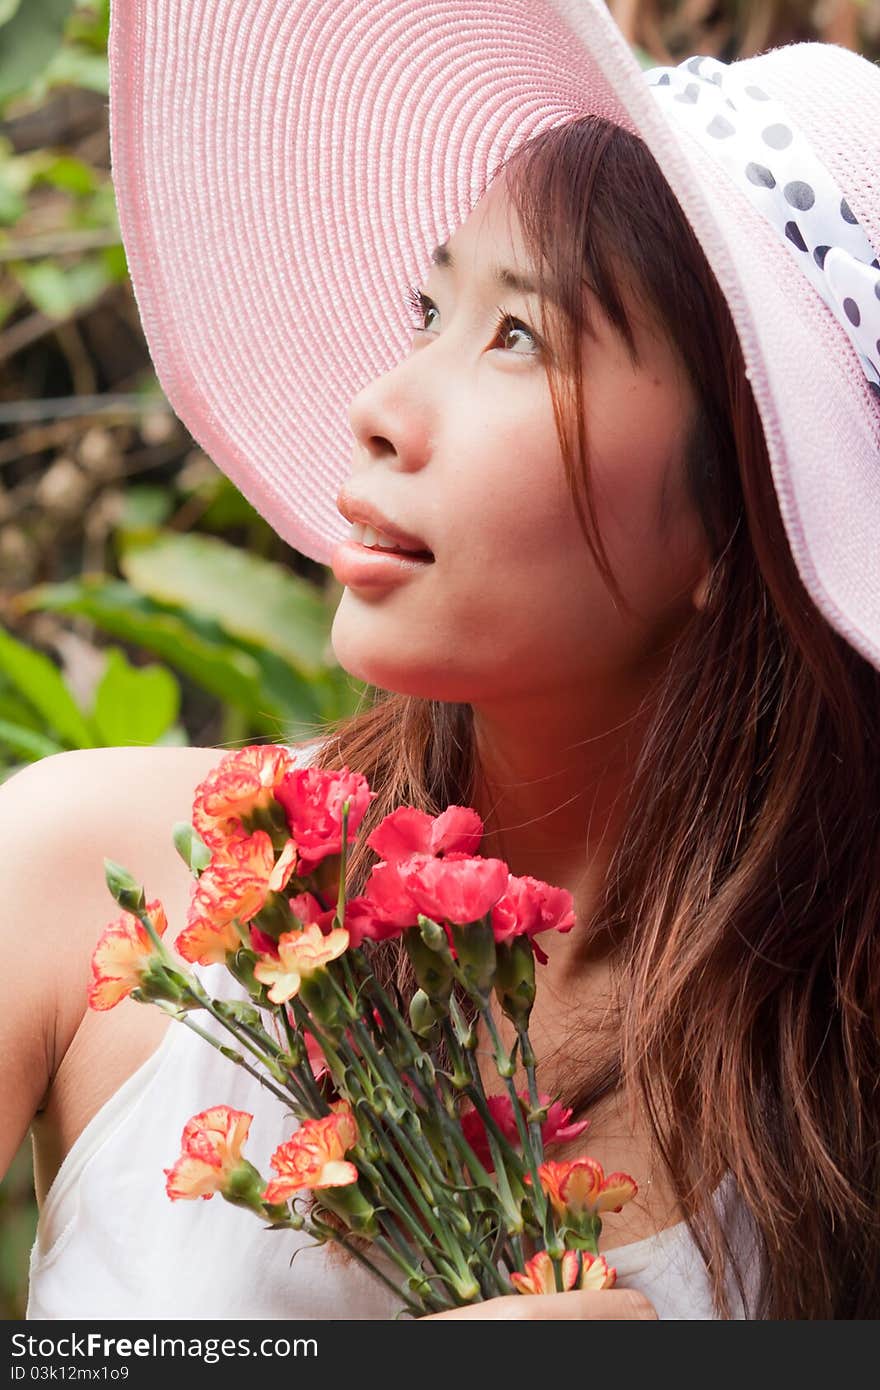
[26,749,758,1321]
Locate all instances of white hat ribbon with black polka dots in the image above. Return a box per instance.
[644,56,880,399]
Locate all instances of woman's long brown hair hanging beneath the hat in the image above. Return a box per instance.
[297,117,880,1318]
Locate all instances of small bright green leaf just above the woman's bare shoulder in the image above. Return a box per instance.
[92,646,181,748]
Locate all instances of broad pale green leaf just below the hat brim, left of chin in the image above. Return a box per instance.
[120,531,329,676]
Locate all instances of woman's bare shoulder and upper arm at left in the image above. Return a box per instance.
[0,746,224,1195]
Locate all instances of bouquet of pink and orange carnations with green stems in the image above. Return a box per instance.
[89,745,637,1316]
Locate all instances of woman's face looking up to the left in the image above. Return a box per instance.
[332,170,705,705]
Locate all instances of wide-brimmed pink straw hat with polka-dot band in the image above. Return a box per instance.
[110,0,880,669]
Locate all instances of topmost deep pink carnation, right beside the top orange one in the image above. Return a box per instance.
[275,767,375,876]
